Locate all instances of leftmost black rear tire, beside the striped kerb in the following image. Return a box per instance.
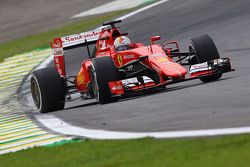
[31,68,66,113]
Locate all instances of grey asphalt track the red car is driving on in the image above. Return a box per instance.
[21,0,250,132]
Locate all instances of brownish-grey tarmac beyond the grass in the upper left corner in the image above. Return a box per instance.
[0,0,111,43]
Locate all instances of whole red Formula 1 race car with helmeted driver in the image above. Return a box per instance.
[31,20,232,113]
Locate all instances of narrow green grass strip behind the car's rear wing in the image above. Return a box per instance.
[0,9,133,62]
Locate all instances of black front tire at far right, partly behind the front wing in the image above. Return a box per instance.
[189,35,222,83]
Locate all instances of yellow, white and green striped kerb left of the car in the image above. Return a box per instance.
[0,49,70,154]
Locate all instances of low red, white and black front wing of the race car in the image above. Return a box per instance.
[108,58,234,96]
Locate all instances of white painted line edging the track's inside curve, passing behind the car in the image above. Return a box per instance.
[32,0,250,139]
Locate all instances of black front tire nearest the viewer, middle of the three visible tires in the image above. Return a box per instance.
[90,56,120,104]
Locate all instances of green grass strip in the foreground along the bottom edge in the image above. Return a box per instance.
[0,135,250,167]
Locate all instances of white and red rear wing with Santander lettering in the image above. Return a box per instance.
[50,27,105,78]
